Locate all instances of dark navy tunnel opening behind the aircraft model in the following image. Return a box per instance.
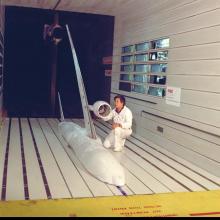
[4,7,114,117]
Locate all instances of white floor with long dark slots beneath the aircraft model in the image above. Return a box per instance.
[0,118,220,201]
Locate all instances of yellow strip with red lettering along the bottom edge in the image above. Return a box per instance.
[0,191,220,217]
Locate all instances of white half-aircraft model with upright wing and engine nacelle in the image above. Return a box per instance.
[58,25,125,186]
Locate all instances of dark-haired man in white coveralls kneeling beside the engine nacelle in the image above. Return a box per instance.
[103,95,132,152]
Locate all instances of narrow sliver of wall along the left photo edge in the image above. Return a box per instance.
[0,0,5,122]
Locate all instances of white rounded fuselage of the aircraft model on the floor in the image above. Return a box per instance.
[59,122,125,186]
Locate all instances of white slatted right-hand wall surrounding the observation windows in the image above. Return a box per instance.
[111,0,220,176]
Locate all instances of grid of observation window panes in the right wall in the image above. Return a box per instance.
[119,38,170,98]
